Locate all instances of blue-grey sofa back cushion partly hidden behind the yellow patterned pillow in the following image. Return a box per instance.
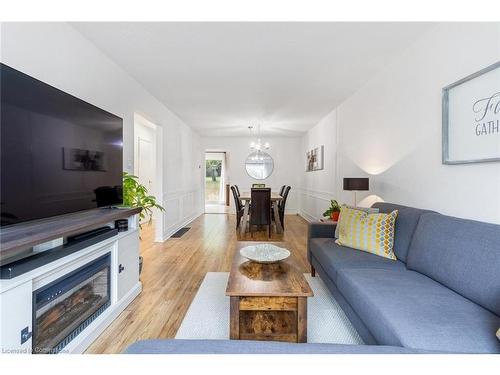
[372,202,432,263]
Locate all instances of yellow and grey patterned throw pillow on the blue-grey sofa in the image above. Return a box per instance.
[335,206,398,260]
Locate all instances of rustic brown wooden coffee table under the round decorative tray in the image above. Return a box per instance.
[226,242,313,342]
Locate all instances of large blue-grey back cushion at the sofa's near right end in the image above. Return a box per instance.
[407,213,500,315]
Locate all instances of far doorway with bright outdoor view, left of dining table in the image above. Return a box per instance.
[205,152,228,214]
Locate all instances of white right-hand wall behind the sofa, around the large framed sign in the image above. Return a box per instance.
[301,23,500,223]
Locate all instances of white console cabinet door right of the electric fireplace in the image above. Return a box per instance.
[117,230,139,301]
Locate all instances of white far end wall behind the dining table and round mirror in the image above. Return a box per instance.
[202,137,305,214]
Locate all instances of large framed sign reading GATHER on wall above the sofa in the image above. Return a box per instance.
[443,62,500,164]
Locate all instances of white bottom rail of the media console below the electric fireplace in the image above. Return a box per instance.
[65,281,142,354]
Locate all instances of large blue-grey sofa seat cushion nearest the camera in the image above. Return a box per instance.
[337,268,500,353]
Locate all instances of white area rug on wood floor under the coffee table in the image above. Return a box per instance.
[175,272,363,344]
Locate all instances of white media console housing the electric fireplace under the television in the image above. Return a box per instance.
[0,210,142,354]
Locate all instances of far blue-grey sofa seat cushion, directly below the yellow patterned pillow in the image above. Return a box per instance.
[309,238,406,282]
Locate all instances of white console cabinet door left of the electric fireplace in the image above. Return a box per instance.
[0,280,33,354]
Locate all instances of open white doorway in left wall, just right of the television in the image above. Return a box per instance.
[134,114,157,224]
